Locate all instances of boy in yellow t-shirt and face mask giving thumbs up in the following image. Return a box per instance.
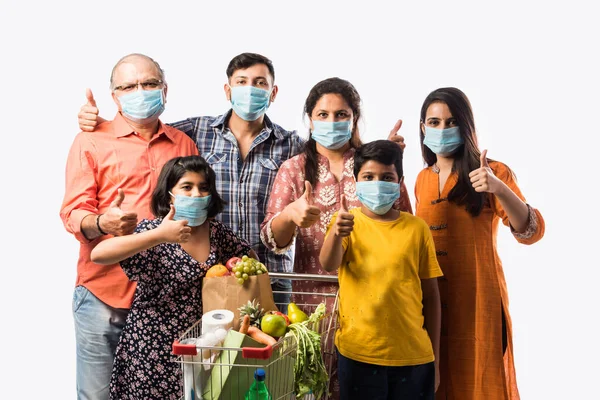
[320,140,442,400]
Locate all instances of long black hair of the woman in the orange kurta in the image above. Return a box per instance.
[419,87,487,216]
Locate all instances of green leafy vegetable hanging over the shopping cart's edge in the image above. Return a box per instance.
[286,303,329,399]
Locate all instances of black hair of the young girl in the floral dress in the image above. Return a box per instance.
[150,156,225,218]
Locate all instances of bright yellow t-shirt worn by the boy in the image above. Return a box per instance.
[327,207,442,366]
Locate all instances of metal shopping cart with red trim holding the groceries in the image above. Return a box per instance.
[173,273,338,400]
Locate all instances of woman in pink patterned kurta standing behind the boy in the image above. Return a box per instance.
[261,78,412,399]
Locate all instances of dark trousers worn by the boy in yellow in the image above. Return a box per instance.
[336,349,435,400]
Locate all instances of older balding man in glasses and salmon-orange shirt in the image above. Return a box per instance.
[60,54,198,399]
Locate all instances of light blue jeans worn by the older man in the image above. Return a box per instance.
[73,286,129,400]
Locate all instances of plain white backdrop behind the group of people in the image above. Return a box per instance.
[0,0,600,399]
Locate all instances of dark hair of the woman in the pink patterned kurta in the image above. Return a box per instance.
[304,78,362,187]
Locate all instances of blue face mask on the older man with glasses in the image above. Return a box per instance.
[119,89,165,124]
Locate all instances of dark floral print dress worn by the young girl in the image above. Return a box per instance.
[110,218,250,400]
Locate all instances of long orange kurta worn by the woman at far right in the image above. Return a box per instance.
[415,161,544,400]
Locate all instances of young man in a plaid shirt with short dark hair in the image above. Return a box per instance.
[79,53,303,303]
